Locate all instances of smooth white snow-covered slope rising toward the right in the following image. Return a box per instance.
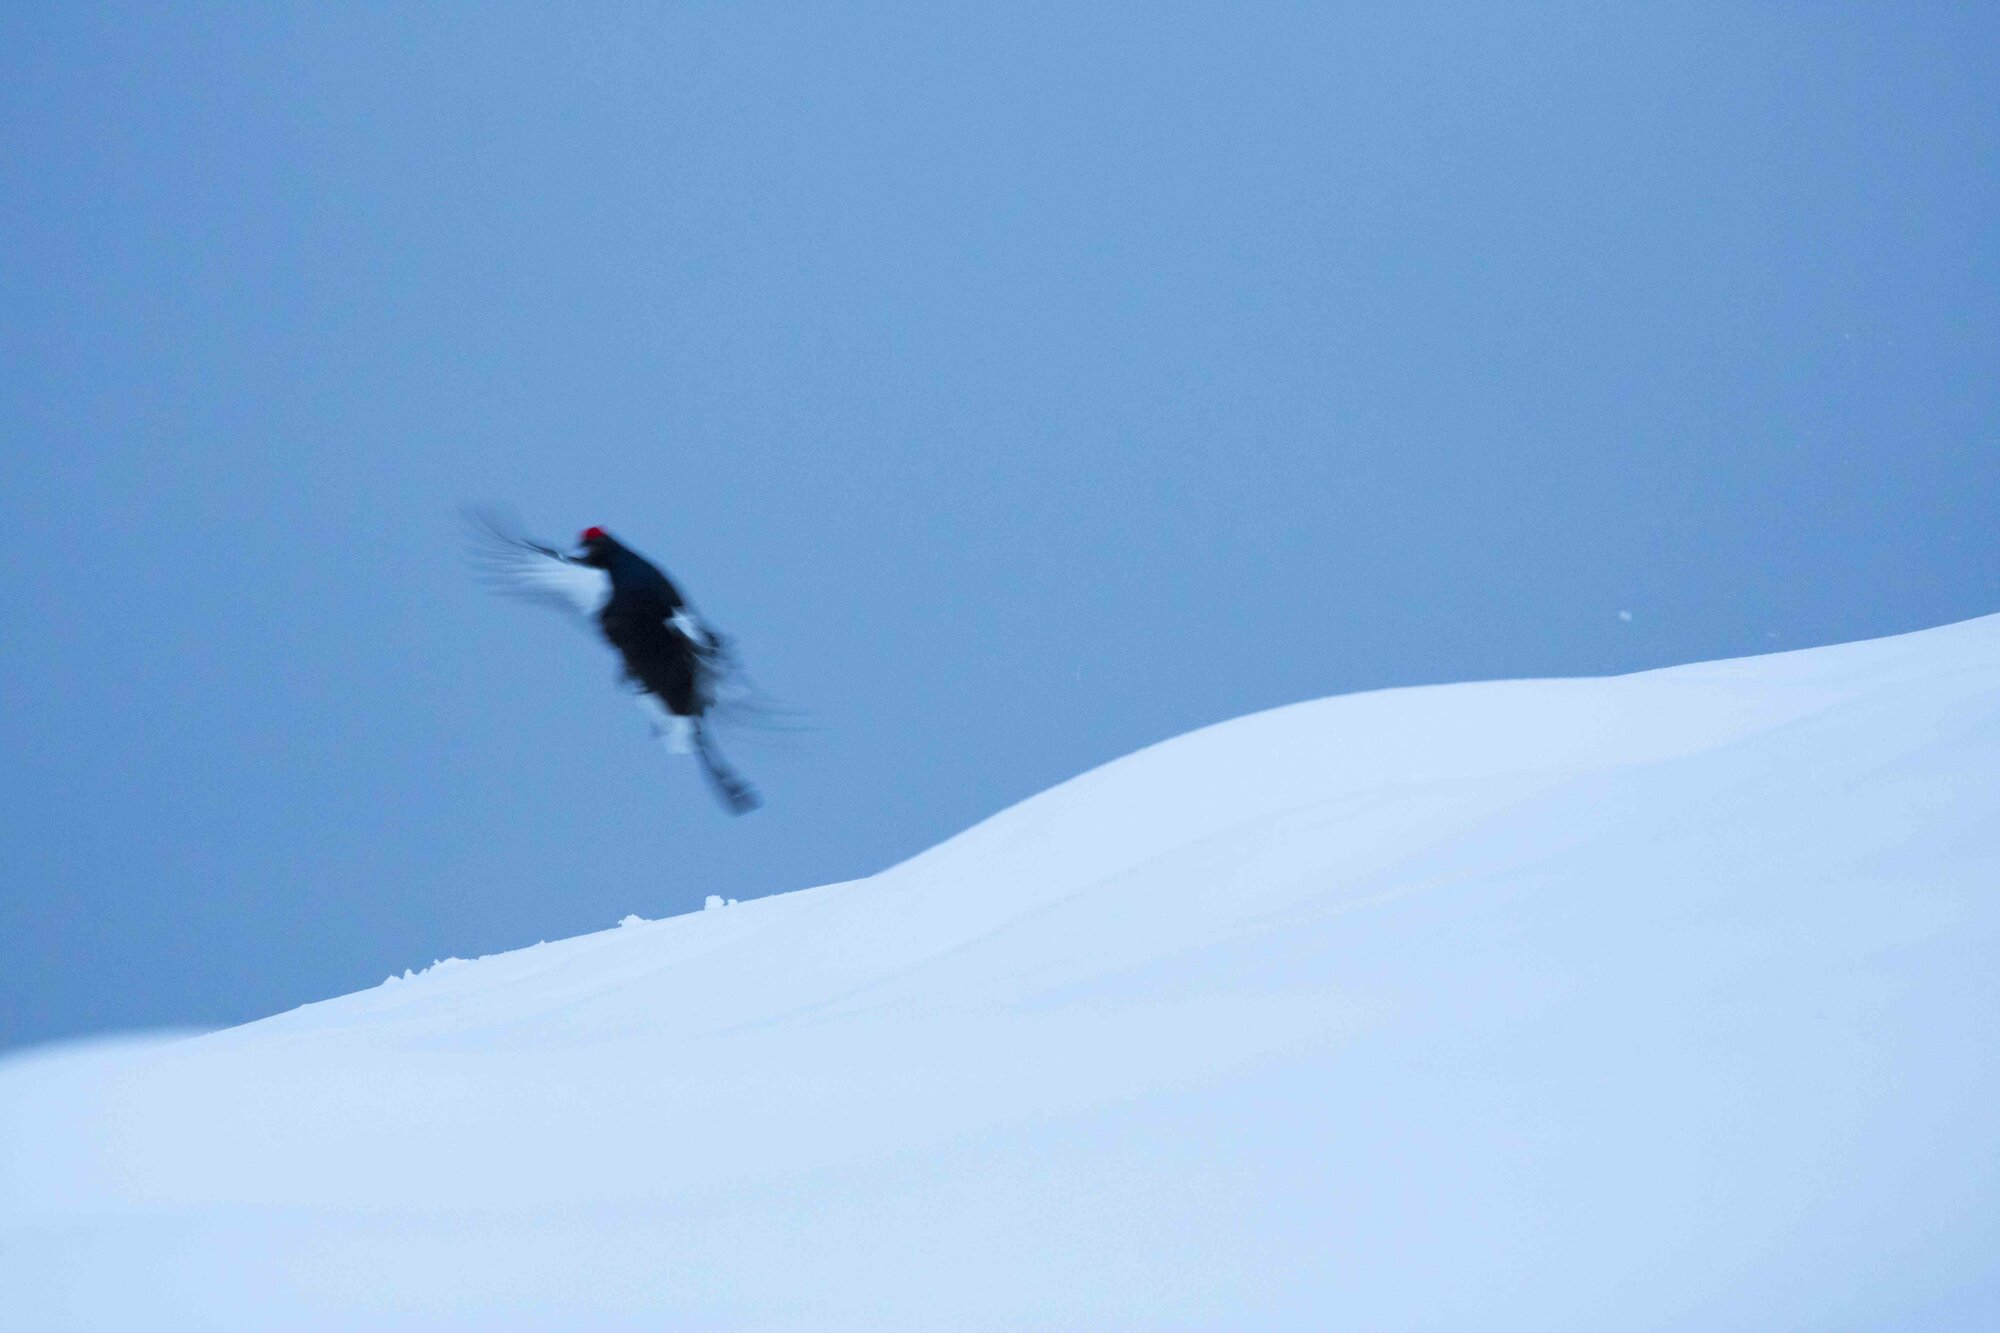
[0,616,2000,1333]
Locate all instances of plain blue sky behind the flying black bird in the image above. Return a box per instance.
[0,4,2000,1045]
